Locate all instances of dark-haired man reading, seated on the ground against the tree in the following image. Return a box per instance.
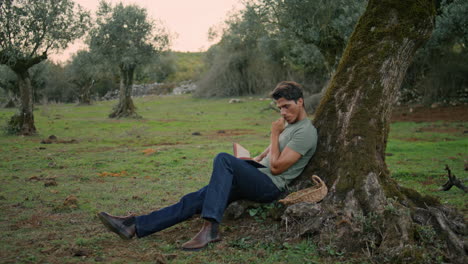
[98,81,317,250]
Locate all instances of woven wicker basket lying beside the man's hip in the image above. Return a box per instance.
[279,175,328,205]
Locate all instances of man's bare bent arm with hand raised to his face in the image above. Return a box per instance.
[269,118,302,175]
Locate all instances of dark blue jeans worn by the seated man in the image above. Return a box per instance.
[136,153,281,237]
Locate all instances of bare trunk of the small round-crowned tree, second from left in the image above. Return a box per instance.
[109,66,140,118]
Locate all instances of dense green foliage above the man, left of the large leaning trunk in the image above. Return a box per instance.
[197,0,366,97]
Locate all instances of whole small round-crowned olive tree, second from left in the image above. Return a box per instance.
[89,1,169,118]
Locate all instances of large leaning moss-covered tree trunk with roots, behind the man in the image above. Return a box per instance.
[283,0,466,262]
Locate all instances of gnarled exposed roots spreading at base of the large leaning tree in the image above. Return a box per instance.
[282,193,468,263]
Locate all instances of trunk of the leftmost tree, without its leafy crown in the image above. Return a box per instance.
[7,70,37,136]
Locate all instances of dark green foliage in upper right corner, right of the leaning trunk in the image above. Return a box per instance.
[401,0,468,104]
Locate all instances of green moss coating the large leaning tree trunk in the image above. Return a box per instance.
[314,0,435,201]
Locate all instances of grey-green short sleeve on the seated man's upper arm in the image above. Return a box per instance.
[286,122,317,156]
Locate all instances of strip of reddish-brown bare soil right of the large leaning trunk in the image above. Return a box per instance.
[392,105,468,122]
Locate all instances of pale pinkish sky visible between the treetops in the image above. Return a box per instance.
[50,0,242,62]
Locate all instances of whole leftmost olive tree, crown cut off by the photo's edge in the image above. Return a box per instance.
[0,0,89,135]
